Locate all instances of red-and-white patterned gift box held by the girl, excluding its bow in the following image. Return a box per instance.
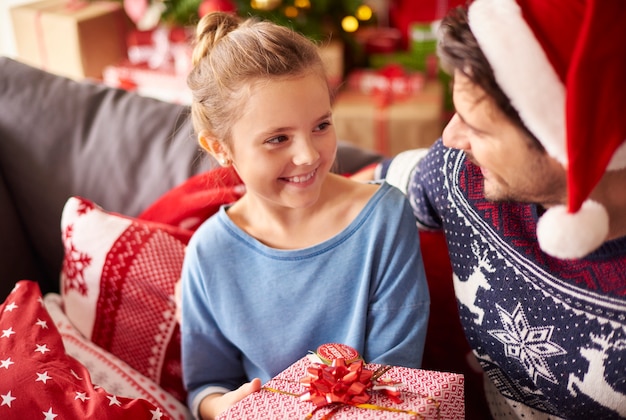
[218,357,465,420]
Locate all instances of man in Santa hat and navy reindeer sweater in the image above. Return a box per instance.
[370,0,626,419]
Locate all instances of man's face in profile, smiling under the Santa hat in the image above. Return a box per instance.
[443,70,567,207]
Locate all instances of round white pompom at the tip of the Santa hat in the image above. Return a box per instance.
[537,200,609,259]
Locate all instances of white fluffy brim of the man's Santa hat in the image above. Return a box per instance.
[468,0,567,166]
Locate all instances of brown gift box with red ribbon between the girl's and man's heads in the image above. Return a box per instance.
[333,80,444,156]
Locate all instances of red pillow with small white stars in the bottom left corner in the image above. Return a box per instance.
[0,280,170,420]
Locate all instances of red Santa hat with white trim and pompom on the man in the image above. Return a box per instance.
[468,0,626,259]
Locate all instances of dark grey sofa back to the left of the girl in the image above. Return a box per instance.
[0,58,213,293]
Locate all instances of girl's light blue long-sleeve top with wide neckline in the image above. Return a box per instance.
[181,183,430,413]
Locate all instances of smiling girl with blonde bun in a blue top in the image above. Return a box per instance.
[181,13,429,418]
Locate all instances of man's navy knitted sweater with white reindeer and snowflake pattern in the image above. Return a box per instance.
[392,140,626,419]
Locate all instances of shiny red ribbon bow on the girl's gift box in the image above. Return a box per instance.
[300,359,373,407]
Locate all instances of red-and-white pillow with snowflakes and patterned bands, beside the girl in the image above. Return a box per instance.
[61,197,192,401]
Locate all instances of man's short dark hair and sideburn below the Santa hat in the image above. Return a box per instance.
[437,6,543,149]
